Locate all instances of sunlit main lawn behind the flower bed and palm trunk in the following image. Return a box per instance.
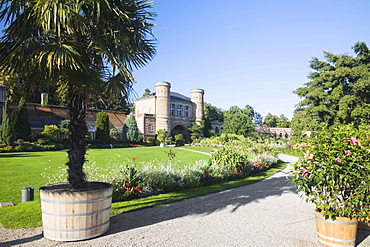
[0,147,209,204]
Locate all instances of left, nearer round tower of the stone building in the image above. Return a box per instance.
[155,82,171,131]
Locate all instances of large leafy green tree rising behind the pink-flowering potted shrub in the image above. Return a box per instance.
[295,42,370,126]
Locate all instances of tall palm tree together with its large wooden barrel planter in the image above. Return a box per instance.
[0,0,155,241]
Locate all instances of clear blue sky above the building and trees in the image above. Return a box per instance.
[134,0,370,119]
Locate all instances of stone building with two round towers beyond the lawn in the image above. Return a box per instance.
[135,82,204,139]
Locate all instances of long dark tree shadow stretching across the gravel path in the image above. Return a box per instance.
[107,168,295,235]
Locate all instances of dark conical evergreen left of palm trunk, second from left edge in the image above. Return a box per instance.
[14,97,31,140]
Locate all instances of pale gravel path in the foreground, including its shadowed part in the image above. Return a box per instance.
[0,155,370,247]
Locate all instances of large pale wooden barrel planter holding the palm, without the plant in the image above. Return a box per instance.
[40,182,113,241]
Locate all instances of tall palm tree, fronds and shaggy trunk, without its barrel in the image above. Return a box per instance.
[0,0,155,190]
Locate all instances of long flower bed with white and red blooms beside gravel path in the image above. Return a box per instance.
[44,148,277,202]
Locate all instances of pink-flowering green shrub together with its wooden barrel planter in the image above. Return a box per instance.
[290,125,370,245]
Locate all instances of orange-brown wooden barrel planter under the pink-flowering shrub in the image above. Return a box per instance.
[315,211,357,246]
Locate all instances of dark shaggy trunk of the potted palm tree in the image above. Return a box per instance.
[67,87,87,190]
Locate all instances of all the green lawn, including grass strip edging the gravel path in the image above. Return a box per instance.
[0,147,285,228]
